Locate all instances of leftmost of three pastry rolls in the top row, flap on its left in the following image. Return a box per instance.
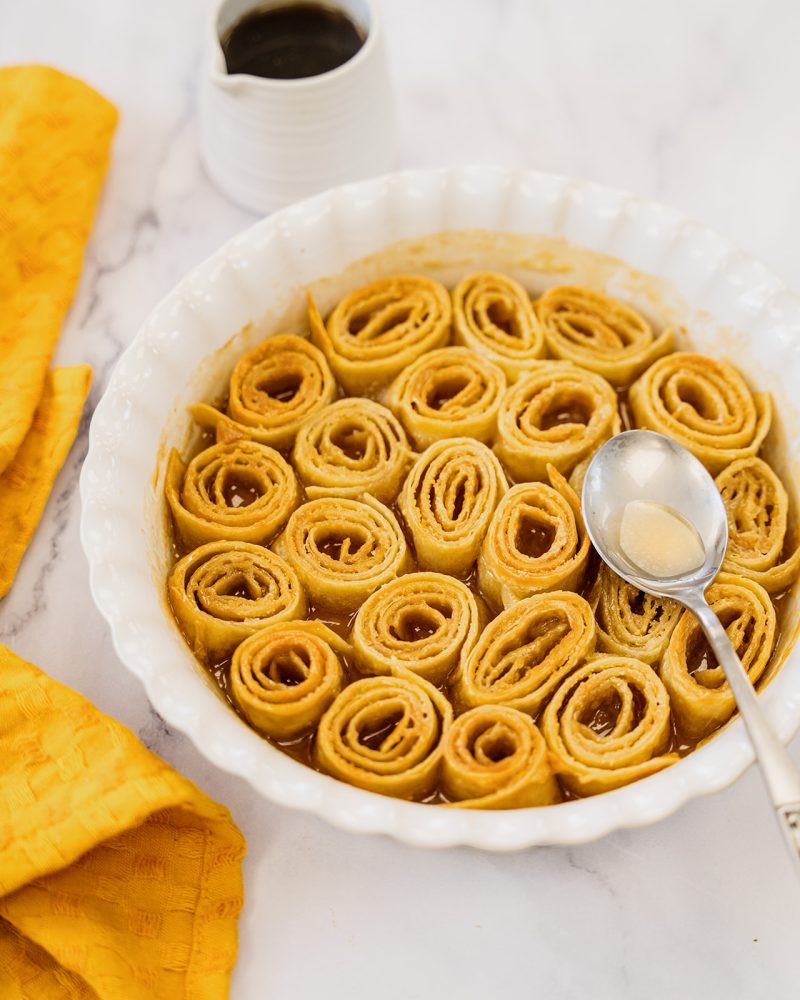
[308,274,452,396]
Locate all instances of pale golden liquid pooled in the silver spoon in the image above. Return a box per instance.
[619,500,706,577]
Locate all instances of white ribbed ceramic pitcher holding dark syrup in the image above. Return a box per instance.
[200,0,395,212]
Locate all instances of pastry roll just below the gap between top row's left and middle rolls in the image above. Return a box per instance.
[386,347,506,448]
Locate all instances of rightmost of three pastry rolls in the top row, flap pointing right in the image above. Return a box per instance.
[536,285,675,386]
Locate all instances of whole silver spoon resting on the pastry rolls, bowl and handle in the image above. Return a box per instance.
[582,431,800,872]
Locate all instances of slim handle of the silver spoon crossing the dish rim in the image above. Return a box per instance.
[689,595,800,873]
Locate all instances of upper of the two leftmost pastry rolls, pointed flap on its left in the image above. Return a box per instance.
[165,441,299,548]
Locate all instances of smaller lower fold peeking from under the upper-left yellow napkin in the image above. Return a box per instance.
[0,365,92,597]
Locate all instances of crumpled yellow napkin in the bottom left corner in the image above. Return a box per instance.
[0,646,244,1000]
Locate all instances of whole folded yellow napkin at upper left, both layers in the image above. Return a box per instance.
[0,66,117,597]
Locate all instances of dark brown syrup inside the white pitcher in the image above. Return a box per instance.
[222,3,365,80]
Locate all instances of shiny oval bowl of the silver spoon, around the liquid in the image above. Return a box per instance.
[582,430,728,605]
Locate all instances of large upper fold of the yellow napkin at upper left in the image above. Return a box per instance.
[0,66,117,472]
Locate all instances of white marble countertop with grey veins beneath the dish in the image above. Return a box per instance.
[0,0,800,1000]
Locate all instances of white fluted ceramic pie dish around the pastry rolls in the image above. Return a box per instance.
[81,167,800,850]
